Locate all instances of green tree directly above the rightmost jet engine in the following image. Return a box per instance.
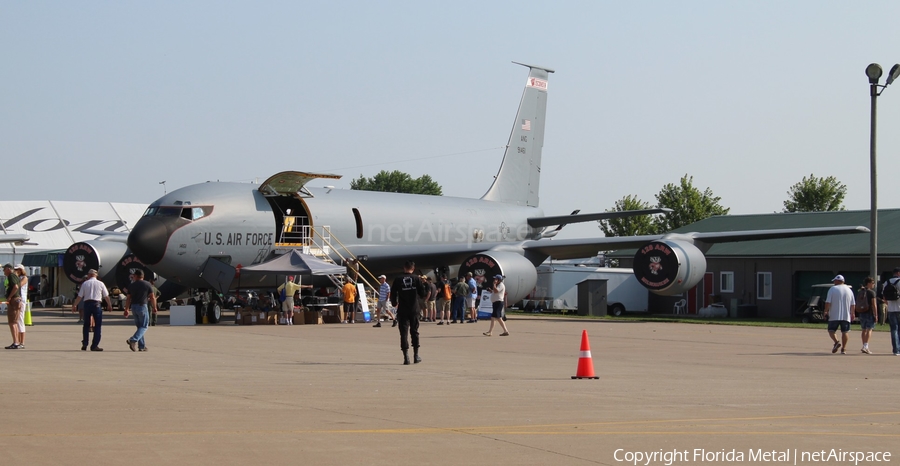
[654,174,731,233]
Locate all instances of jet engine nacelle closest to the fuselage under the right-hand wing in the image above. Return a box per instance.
[459,251,537,304]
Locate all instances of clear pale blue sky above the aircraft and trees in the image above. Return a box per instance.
[0,0,900,237]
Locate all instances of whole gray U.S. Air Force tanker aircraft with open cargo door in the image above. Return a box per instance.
[112,63,868,316]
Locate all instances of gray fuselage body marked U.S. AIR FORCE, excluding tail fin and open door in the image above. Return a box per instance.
[129,182,543,287]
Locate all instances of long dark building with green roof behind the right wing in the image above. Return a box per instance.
[609,209,900,318]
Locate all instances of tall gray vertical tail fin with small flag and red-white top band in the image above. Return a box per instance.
[481,62,553,207]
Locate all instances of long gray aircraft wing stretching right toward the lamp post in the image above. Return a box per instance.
[523,226,869,259]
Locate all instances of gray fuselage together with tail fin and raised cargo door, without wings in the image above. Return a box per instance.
[128,65,553,294]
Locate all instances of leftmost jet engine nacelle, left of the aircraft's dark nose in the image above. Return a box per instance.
[63,241,128,286]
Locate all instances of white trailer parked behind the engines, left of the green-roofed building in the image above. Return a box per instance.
[530,262,649,316]
